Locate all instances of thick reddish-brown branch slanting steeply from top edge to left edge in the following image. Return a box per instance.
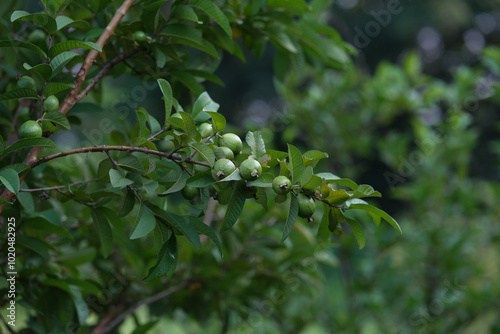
[0,0,135,213]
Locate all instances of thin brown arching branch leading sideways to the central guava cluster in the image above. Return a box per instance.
[29,145,210,168]
